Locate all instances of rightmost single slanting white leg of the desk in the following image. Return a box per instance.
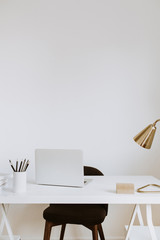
[146,204,157,240]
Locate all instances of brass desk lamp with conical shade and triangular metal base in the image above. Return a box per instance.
[133,119,160,193]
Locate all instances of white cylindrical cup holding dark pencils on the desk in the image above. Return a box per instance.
[13,172,27,193]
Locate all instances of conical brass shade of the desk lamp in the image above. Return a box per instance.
[133,124,156,149]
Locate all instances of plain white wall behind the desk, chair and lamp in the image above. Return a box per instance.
[0,0,160,238]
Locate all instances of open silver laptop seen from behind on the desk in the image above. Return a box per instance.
[35,149,84,187]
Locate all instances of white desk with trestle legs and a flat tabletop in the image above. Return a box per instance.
[0,176,160,240]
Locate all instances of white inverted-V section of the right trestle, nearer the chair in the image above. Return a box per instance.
[125,204,144,240]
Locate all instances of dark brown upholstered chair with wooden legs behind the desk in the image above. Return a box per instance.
[43,166,108,240]
